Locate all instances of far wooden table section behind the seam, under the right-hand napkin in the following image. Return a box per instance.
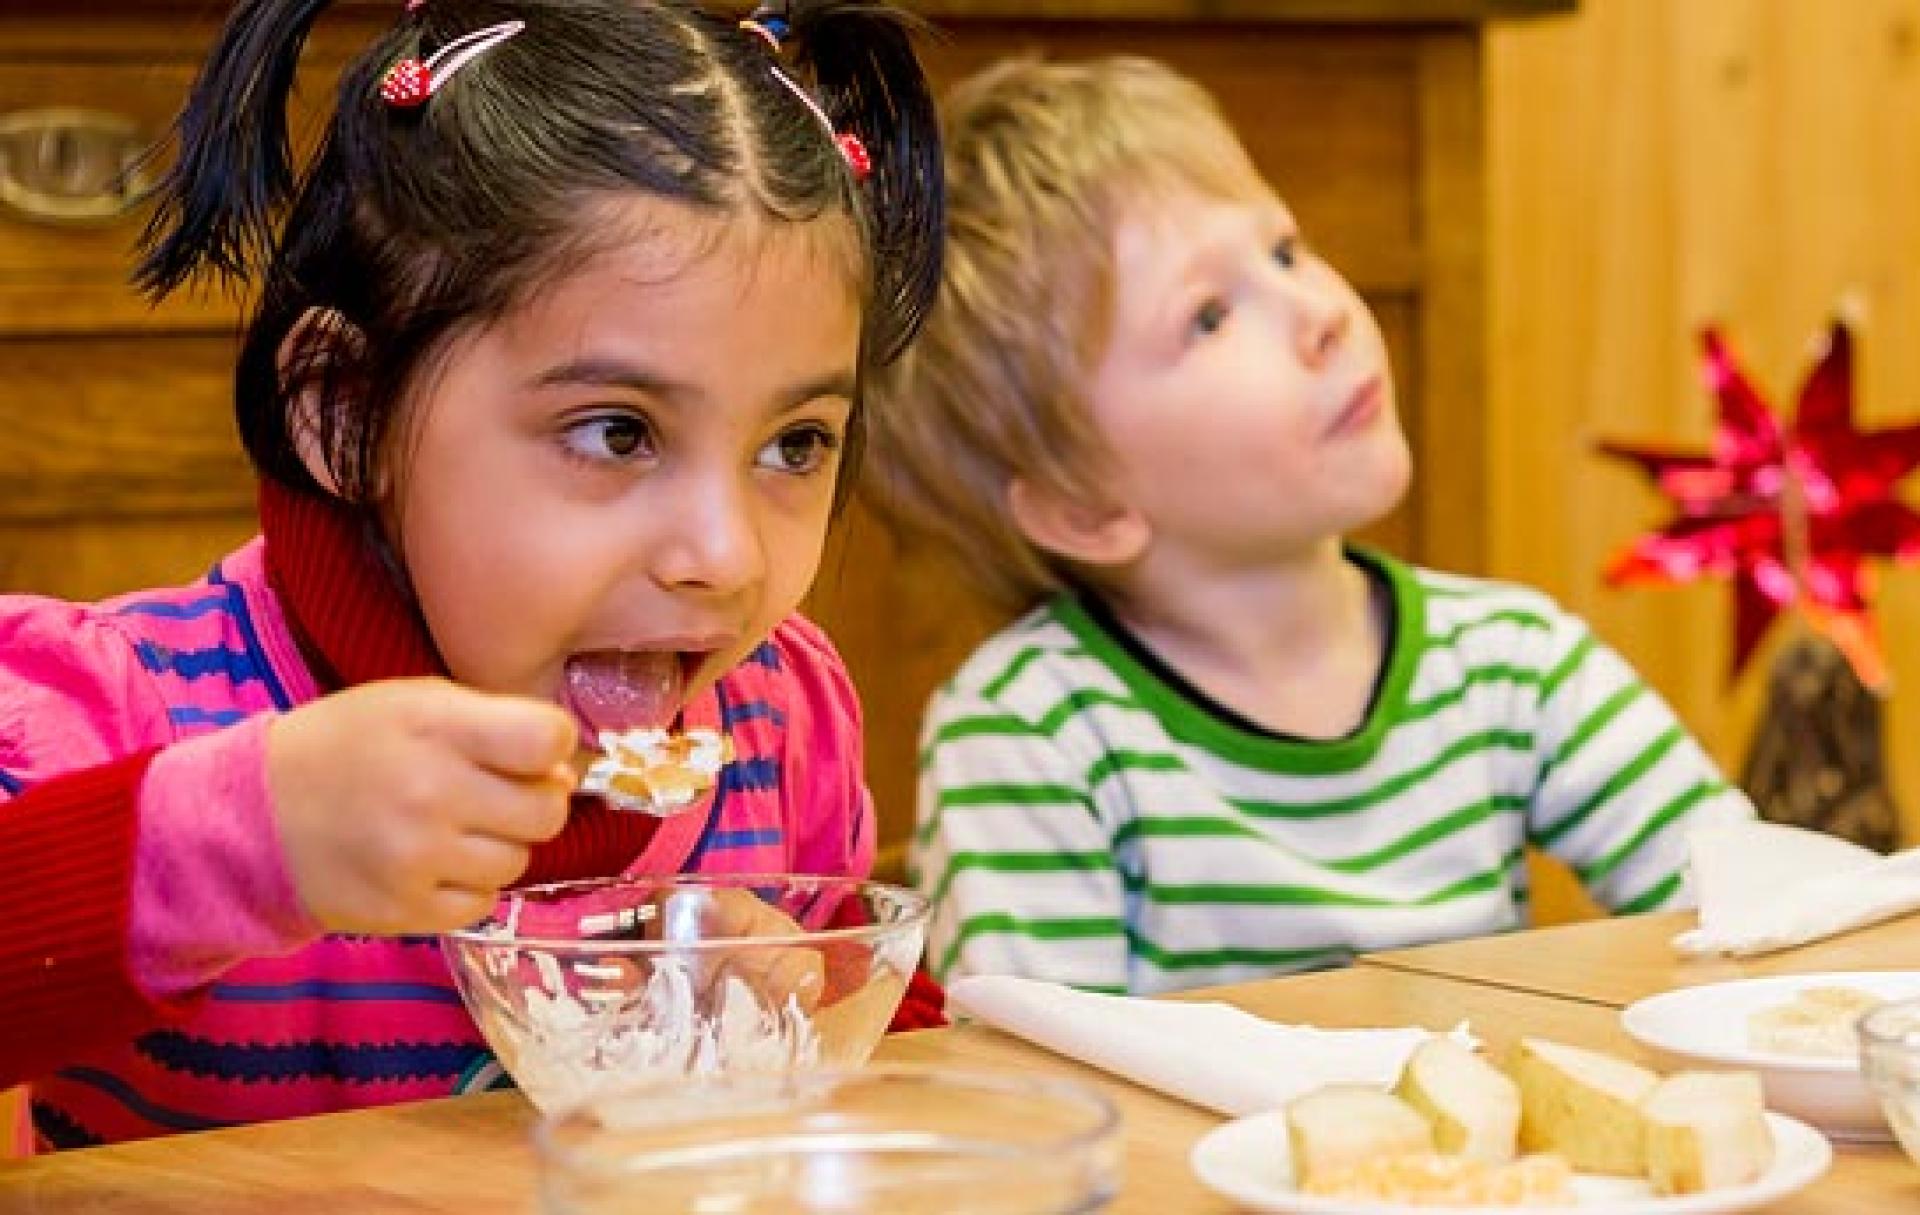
[1363,912,1920,1008]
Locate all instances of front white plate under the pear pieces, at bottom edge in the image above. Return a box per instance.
[1188,1111,1834,1215]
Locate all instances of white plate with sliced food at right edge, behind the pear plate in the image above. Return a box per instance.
[1620,971,1920,1142]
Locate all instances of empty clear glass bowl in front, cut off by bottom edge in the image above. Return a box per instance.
[534,1067,1121,1215]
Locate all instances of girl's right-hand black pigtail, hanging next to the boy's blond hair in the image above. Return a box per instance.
[785,0,947,363]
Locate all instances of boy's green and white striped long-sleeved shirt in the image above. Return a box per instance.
[910,553,1753,992]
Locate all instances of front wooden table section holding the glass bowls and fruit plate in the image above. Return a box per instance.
[0,921,1920,1215]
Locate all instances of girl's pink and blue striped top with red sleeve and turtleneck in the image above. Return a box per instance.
[0,489,874,1148]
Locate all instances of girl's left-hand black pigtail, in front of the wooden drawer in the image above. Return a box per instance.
[134,0,341,299]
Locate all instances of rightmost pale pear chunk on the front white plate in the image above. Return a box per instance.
[1640,1071,1774,1194]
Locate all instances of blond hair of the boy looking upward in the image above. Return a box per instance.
[868,58,1265,610]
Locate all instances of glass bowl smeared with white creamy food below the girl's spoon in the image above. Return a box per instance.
[442,873,927,1109]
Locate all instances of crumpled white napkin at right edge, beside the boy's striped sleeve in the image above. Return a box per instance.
[1674,822,1920,956]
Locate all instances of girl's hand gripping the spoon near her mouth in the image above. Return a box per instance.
[267,679,576,933]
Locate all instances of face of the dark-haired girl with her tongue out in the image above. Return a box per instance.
[382,200,860,741]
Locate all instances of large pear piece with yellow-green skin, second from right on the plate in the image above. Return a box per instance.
[1513,1038,1659,1177]
